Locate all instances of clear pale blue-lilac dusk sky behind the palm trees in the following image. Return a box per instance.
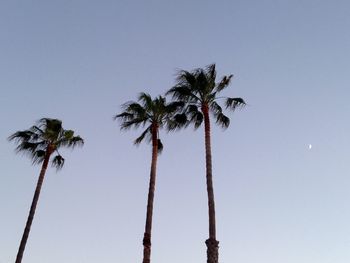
[0,0,350,263]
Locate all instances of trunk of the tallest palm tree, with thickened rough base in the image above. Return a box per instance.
[202,105,219,263]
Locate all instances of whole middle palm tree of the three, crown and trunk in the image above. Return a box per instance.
[115,93,185,263]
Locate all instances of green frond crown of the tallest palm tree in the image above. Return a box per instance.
[167,64,246,129]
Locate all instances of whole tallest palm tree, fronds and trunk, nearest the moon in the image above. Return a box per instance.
[167,64,245,263]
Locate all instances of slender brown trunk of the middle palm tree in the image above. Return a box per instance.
[142,124,158,263]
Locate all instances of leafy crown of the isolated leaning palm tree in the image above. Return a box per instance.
[8,118,84,169]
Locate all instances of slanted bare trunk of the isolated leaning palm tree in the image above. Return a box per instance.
[15,147,52,263]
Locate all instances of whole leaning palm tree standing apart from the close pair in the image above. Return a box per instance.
[8,118,84,263]
